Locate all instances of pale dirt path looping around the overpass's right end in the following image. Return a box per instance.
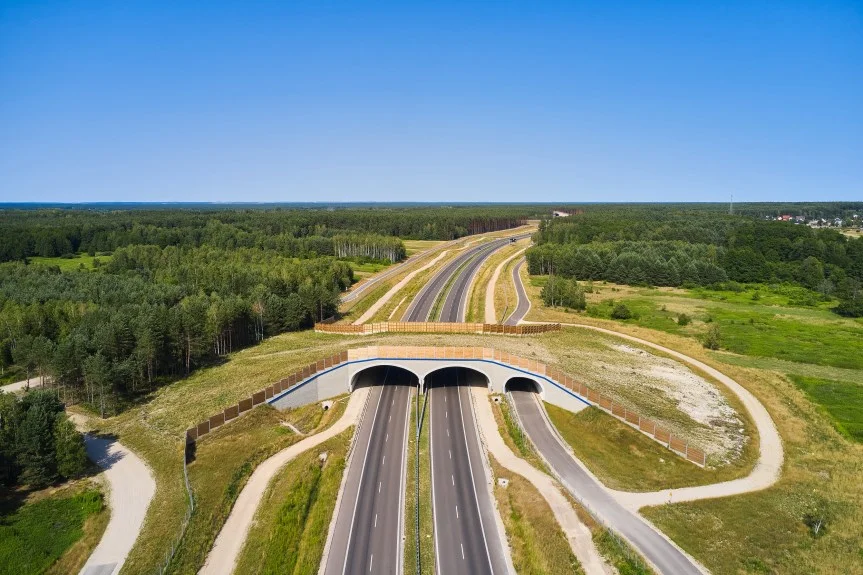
[523,321,784,510]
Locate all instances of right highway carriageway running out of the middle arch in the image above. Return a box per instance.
[428,368,506,575]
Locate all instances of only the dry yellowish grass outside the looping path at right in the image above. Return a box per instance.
[528,278,863,574]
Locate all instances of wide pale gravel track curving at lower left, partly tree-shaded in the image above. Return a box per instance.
[80,434,156,575]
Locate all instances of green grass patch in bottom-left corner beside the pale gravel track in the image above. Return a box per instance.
[0,480,110,575]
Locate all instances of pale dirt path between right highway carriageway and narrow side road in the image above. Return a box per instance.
[471,387,614,575]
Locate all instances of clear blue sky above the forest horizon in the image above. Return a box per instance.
[0,0,863,202]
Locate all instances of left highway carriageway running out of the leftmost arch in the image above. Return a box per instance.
[324,368,416,575]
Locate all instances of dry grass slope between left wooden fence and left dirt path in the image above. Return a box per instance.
[169,401,344,573]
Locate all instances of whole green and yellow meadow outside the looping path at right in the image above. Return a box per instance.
[520,278,863,574]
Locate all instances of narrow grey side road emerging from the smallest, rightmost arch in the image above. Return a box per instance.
[511,390,701,575]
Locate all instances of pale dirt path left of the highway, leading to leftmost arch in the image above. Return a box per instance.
[198,388,368,575]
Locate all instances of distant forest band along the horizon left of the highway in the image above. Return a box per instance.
[0,206,532,262]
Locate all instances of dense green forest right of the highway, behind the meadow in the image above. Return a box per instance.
[527,205,863,316]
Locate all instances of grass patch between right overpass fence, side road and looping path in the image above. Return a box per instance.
[545,403,757,491]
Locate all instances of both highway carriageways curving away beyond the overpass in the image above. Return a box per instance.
[405,234,529,321]
